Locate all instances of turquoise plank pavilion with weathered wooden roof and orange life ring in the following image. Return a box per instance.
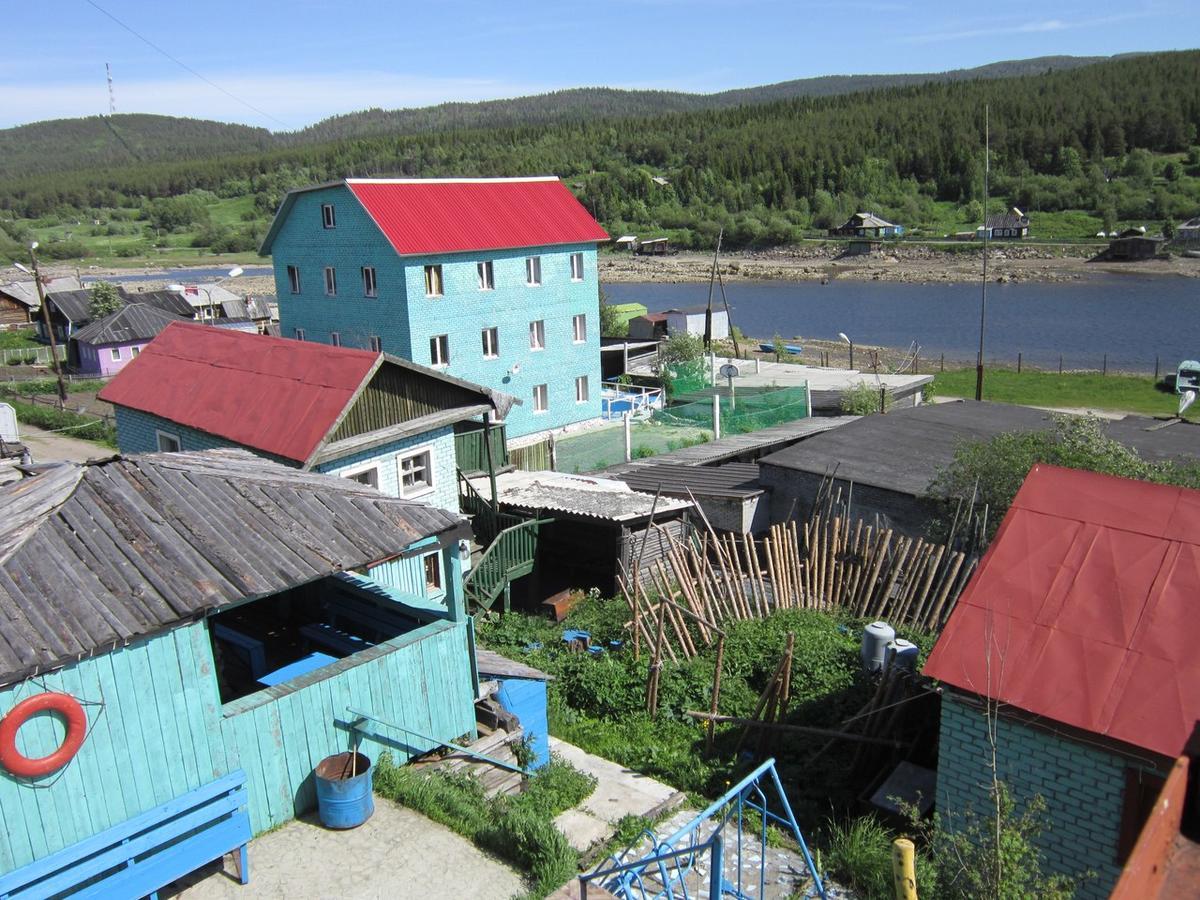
[0,450,476,896]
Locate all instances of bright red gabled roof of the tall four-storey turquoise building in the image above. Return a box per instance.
[259,175,608,256]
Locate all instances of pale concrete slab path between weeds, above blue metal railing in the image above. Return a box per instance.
[550,738,685,851]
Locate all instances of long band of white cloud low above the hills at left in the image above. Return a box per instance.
[0,72,558,130]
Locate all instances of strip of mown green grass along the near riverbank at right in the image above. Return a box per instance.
[934,368,1200,420]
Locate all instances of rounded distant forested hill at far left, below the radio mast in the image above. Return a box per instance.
[0,114,274,179]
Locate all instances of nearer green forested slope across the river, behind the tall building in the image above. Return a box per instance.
[0,50,1200,254]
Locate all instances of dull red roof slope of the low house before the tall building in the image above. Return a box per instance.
[100,323,383,463]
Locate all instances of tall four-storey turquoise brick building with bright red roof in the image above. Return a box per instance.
[262,178,607,438]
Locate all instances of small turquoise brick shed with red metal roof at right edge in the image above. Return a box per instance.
[924,464,1200,900]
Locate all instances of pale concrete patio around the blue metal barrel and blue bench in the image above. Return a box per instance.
[171,797,526,900]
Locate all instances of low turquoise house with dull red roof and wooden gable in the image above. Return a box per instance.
[100,323,512,512]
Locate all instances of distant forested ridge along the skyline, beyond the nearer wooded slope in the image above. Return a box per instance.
[0,56,1118,179]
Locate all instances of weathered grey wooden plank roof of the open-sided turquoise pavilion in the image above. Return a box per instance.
[0,450,460,684]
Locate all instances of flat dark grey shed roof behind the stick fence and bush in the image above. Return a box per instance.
[758,401,1200,497]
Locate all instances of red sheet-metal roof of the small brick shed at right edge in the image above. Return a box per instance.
[925,466,1200,756]
